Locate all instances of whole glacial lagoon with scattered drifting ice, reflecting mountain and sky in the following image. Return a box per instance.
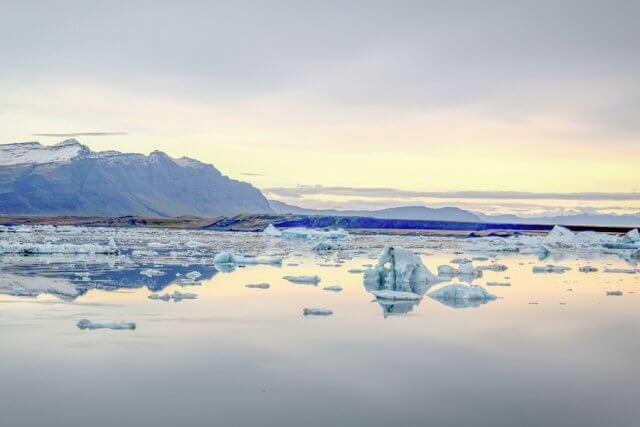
[0,227,640,427]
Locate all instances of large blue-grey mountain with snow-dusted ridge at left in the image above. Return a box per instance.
[0,139,272,217]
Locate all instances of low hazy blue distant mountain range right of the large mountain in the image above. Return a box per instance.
[269,200,640,227]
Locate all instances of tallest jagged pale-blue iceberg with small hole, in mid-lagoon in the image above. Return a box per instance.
[364,246,442,295]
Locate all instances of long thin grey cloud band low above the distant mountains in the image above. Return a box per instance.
[262,185,640,201]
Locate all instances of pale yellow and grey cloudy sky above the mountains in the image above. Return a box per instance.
[0,0,640,214]
